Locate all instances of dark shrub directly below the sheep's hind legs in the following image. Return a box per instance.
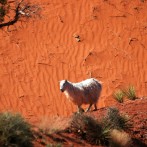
[70,114,110,145]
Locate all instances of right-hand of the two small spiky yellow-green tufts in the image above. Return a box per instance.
[123,86,137,100]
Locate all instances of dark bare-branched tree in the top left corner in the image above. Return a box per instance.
[0,0,40,29]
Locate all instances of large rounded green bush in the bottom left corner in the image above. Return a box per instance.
[0,112,33,147]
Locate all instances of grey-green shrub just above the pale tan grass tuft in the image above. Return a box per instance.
[102,107,129,130]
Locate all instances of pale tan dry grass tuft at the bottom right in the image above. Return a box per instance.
[110,129,132,147]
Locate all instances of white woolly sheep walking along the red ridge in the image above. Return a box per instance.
[60,78,102,112]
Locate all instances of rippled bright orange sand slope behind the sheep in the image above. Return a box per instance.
[0,0,147,121]
